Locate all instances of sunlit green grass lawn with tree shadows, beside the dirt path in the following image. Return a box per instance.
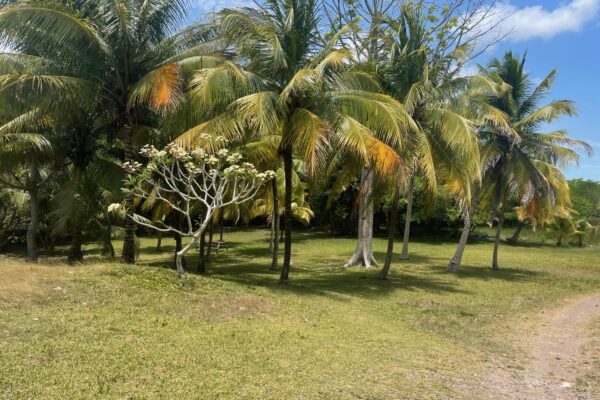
[0,230,600,400]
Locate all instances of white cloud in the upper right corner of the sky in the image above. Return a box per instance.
[494,0,600,41]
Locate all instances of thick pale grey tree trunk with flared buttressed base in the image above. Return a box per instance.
[344,168,377,268]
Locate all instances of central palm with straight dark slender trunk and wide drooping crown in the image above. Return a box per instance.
[179,0,412,283]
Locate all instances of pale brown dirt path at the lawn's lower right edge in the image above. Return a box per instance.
[482,294,600,400]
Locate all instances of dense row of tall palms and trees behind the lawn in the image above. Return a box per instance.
[0,0,591,282]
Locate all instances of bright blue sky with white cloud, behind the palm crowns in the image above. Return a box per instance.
[195,0,600,180]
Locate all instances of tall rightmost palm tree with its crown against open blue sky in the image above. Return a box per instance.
[481,52,591,269]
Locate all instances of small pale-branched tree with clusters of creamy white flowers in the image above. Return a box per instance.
[109,138,275,276]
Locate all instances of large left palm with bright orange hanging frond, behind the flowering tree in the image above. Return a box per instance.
[0,0,210,263]
